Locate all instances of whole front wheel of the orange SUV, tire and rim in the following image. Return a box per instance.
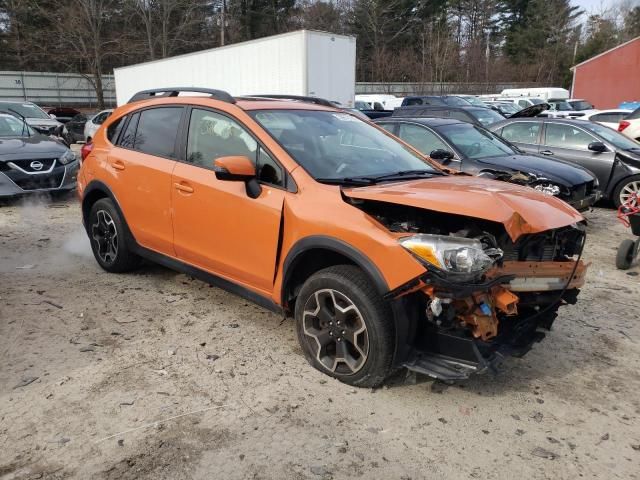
[295,265,395,387]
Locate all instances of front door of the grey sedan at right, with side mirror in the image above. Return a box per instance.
[540,121,616,191]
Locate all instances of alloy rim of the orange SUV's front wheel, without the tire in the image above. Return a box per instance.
[302,289,369,375]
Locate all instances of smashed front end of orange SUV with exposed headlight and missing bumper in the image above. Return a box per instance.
[353,201,586,381]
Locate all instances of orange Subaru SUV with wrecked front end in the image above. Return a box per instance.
[78,88,586,387]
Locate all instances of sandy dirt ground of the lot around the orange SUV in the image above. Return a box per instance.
[0,193,640,479]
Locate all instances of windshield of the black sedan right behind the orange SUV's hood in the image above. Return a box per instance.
[437,123,518,159]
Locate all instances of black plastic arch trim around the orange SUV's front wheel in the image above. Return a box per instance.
[281,235,389,305]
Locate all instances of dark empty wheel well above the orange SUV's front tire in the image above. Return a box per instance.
[282,248,358,312]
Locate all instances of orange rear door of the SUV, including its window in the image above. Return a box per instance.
[106,106,184,256]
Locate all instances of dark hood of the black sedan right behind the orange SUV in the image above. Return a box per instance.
[474,155,595,188]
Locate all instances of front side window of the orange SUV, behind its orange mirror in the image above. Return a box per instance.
[187,109,284,186]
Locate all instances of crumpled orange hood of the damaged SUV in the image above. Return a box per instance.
[343,175,584,241]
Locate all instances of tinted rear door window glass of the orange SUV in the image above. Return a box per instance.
[133,107,182,158]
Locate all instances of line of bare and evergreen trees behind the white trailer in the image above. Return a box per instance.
[0,0,640,108]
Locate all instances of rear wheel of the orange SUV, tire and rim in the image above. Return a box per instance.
[87,198,140,273]
